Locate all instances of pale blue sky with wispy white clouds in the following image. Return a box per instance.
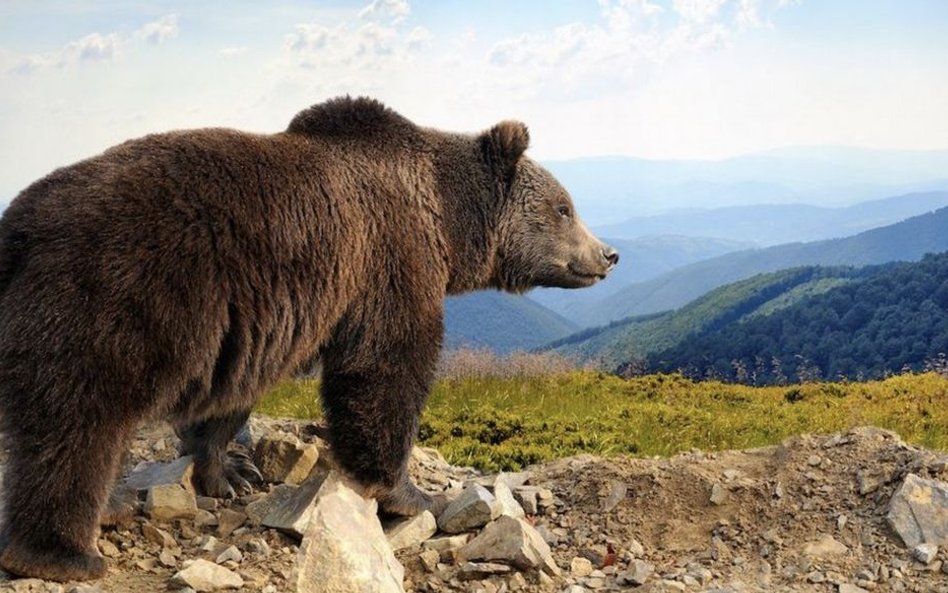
[0,0,948,202]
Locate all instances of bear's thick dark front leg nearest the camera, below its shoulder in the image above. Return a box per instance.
[322,315,441,516]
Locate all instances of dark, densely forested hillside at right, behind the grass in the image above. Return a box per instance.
[643,253,948,383]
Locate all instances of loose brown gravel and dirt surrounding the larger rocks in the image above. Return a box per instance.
[0,418,948,593]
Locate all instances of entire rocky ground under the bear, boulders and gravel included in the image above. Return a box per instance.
[0,419,948,593]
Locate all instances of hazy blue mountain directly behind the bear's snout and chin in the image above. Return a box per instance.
[530,236,753,319]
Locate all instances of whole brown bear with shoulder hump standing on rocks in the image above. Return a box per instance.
[0,97,618,580]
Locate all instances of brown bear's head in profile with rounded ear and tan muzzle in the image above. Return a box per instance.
[480,121,619,292]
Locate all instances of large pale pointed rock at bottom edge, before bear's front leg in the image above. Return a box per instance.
[290,471,405,593]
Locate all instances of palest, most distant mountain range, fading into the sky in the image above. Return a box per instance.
[544,146,948,224]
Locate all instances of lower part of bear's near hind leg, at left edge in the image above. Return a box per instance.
[0,410,129,581]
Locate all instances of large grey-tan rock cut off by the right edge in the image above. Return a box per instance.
[886,474,948,548]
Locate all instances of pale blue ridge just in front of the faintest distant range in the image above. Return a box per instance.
[593,191,948,247]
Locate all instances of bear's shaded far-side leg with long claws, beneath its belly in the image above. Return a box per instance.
[175,410,263,498]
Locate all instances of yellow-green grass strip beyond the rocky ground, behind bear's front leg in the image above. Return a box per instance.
[257,371,948,471]
